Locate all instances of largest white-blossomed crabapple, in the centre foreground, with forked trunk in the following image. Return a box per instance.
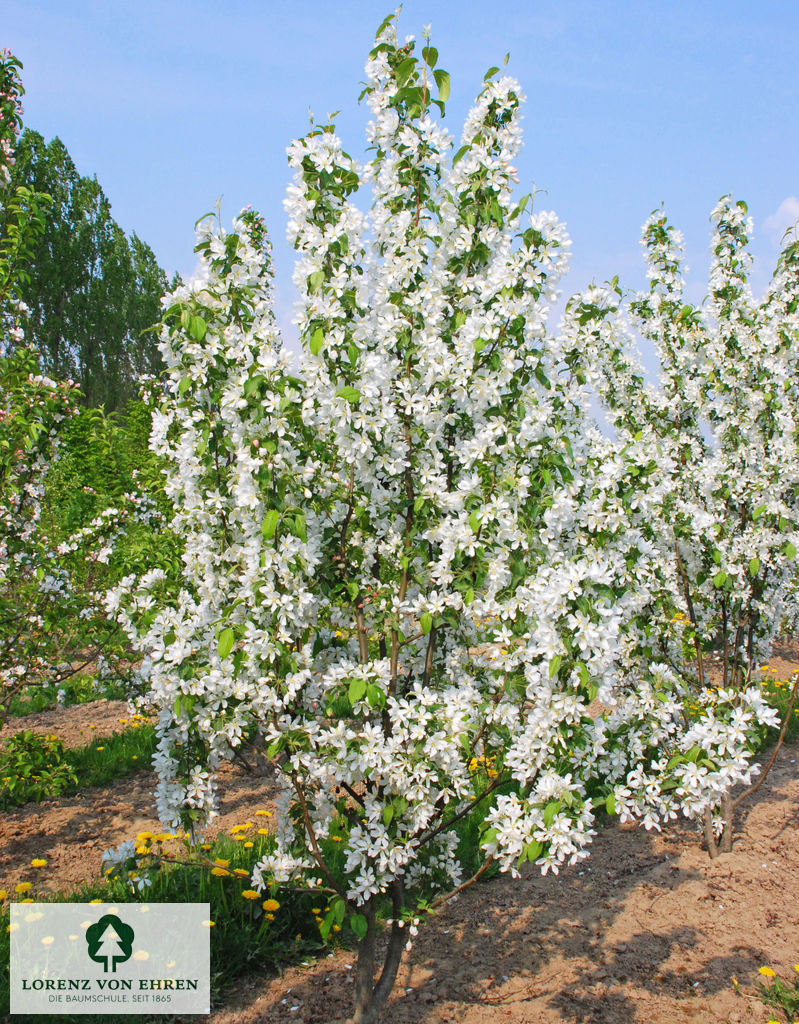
[108,16,733,1024]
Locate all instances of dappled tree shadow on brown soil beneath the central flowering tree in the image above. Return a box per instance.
[227,823,750,1024]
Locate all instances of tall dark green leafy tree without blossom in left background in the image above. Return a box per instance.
[3,129,168,412]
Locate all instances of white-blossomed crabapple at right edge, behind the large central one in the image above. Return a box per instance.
[563,197,799,856]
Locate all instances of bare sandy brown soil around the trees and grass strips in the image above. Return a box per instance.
[0,645,799,1024]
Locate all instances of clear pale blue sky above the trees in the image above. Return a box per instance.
[6,0,799,348]
